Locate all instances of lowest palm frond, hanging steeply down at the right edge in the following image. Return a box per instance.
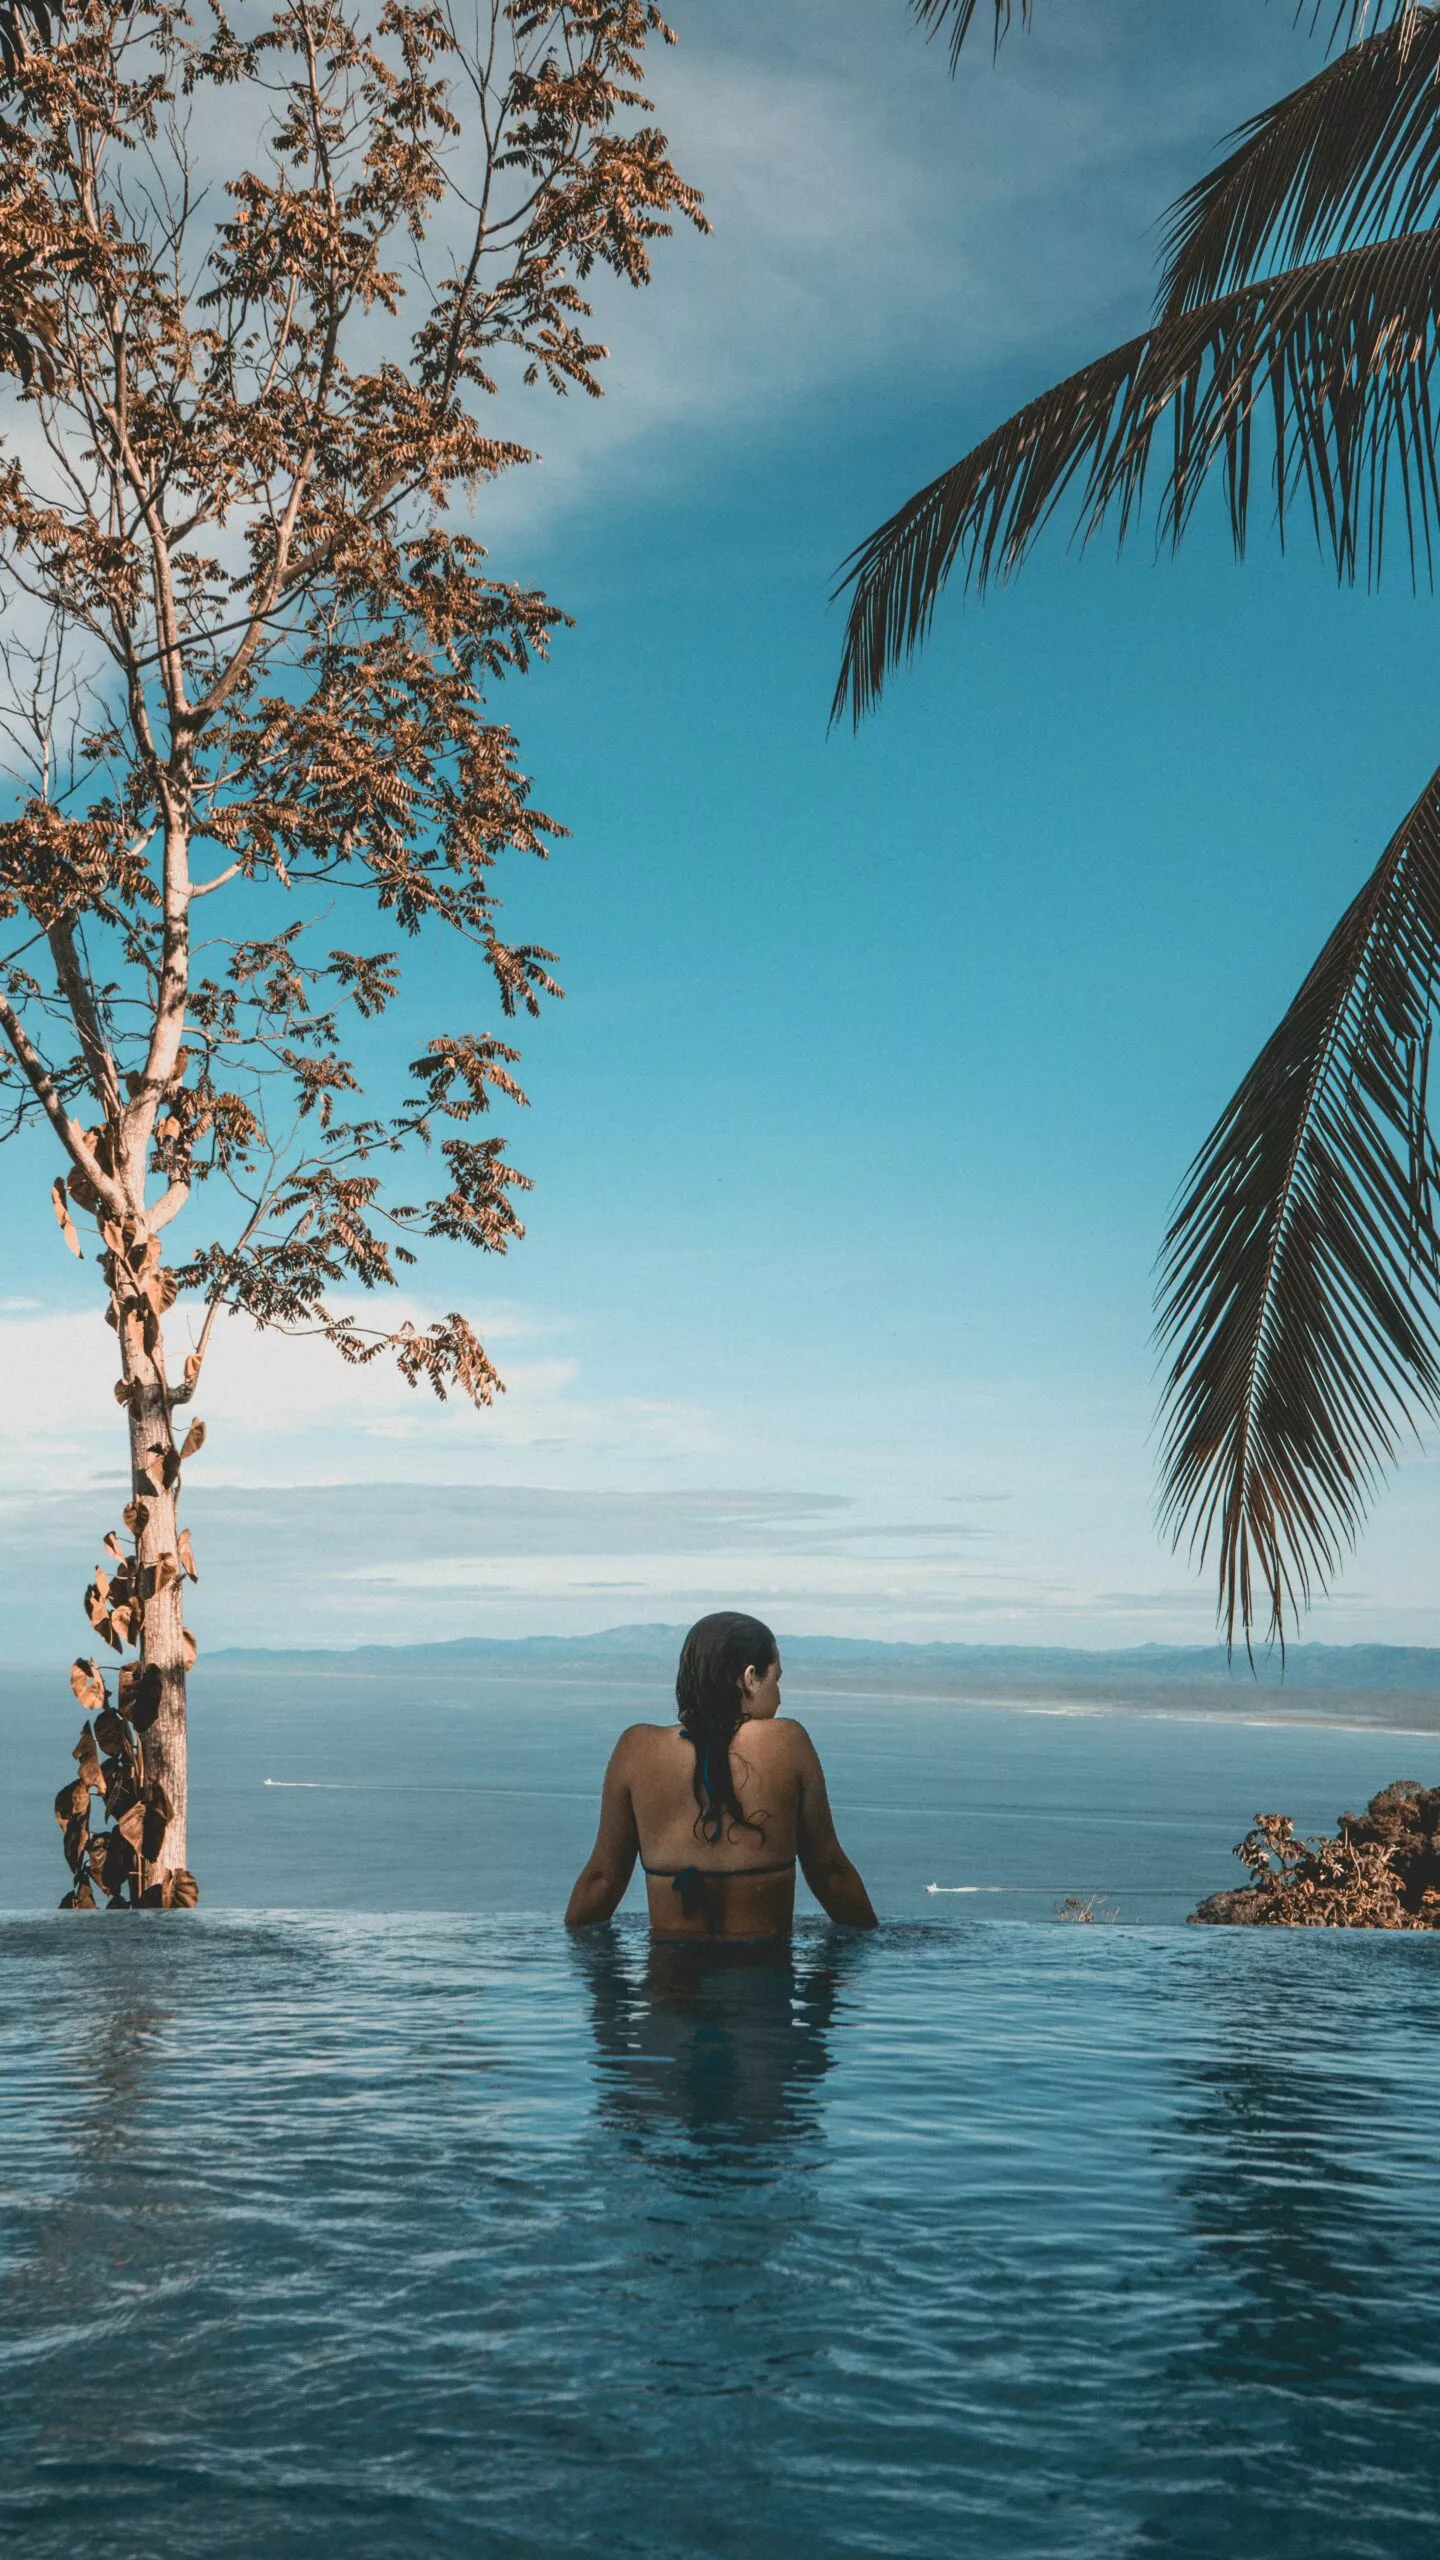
[1161,773,1440,1644]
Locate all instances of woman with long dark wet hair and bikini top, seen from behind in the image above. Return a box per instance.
[566,1610,876,1938]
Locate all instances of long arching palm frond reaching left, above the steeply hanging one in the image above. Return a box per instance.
[830,228,1440,722]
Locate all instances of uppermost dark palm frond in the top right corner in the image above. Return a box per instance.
[1158,5,1440,312]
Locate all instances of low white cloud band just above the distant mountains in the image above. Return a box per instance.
[0,1306,1440,1659]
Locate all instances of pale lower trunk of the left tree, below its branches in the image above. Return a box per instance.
[118,1298,190,1882]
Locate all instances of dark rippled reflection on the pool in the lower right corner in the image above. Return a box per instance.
[1135,1938,1440,2560]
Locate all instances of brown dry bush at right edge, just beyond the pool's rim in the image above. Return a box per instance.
[1191,1779,1440,1928]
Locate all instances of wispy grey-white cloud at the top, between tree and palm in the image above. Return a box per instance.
[471,0,1312,566]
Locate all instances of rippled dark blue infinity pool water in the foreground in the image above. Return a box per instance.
[0,1914,1440,2560]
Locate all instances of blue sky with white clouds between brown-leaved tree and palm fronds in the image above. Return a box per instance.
[0,0,1440,1659]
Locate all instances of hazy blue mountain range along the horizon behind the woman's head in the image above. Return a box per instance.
[210,1626,1440,1718]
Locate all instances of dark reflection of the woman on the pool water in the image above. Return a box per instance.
[574,1928,866,2179]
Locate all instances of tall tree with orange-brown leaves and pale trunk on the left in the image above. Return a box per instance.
[0,0,705,1900]
